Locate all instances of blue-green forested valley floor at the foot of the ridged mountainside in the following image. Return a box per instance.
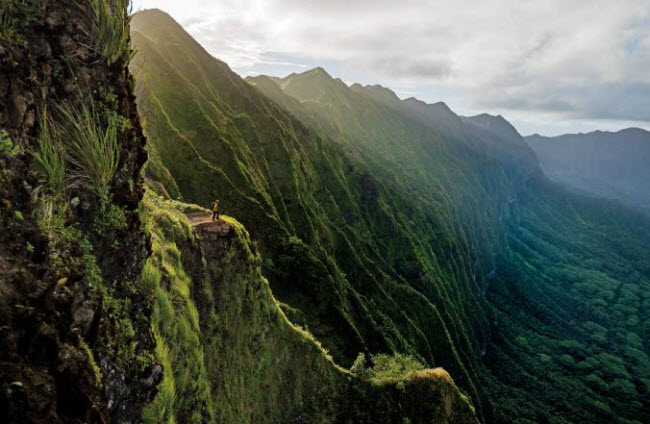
[482,180,650,423]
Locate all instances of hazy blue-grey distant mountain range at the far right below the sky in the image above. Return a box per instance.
[525,128,650,210]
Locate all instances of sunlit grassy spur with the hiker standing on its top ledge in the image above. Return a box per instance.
[142,193,477,423]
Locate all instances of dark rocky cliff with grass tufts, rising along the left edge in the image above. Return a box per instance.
[0,0,156,423]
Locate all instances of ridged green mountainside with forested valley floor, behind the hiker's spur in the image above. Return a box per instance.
[132,11,650,423]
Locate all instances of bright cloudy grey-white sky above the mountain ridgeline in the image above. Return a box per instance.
[133,0,650,135]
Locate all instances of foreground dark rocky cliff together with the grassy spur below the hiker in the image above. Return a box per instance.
[0,0,477,424]
